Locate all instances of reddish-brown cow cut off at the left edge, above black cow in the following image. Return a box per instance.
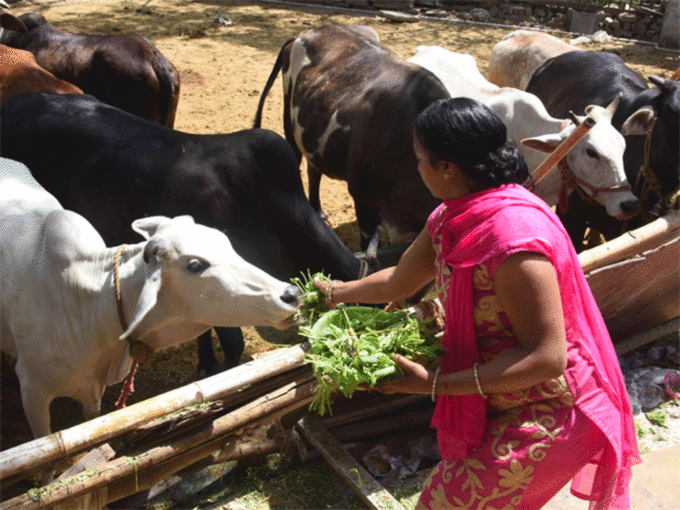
[0,44,83,103]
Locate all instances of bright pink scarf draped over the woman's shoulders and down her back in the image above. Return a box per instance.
[428,185,640,502]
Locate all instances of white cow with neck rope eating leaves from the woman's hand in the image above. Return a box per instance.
[0,158,299,438]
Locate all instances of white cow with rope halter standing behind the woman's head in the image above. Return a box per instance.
[409,46,639,219]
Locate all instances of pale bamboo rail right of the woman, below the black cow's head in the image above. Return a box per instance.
[578,211,680,273]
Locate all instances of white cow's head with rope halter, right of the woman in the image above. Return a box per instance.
[522,99,640,220]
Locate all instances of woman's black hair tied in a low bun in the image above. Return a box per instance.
[414,97,529,189]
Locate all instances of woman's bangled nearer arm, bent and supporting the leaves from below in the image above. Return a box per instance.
[379,252,567,395]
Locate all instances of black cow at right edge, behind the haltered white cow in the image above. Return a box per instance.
[527,51,680,247]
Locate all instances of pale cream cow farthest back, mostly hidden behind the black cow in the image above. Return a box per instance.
[489,30,584,90]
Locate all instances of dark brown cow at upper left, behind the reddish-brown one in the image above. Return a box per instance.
[0,13,179,127]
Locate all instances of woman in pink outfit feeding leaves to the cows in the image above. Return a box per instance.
[317,98,640,510]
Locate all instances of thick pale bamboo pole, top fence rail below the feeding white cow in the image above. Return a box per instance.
[0,344,306,480]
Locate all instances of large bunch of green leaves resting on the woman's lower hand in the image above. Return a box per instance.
[300,306,441,415]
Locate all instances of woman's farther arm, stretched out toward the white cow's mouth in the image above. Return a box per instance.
[315,230,437,304]
